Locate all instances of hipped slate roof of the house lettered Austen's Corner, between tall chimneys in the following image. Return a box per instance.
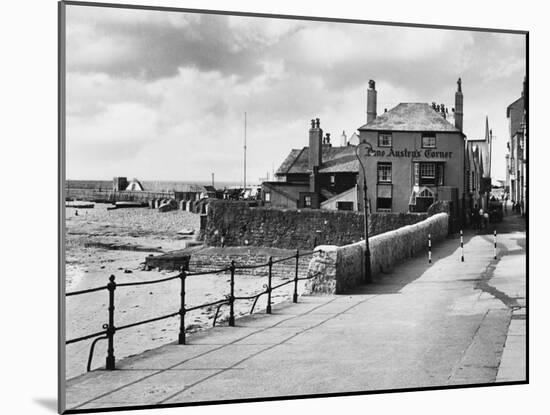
[359,102,461,133]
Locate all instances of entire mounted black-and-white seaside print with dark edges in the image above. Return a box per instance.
[59,1,529,413]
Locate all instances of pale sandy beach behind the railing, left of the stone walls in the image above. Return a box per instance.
[65,203,310,379]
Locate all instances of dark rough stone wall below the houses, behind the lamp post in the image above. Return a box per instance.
[201,201,427,250]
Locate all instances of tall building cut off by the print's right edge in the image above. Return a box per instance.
[506,80,527,218]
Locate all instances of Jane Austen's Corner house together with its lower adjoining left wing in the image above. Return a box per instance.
[262,79,472,226]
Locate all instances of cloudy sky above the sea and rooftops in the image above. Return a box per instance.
[66,5,526,183]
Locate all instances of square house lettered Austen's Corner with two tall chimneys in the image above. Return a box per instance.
[357,79,465,223]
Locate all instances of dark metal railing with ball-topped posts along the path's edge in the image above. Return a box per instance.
[65,250,316,372]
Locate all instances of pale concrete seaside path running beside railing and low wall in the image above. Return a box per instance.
[67,217,526,409]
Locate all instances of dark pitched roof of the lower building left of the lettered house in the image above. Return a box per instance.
[275,145,359,176]
